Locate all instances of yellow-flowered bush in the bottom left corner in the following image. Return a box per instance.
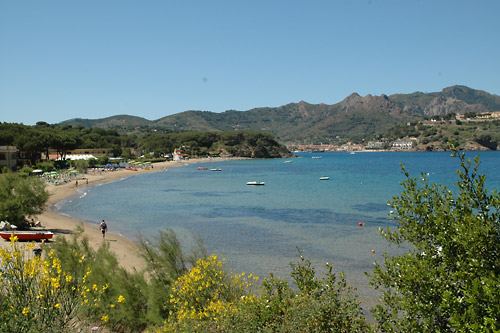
[0,236,106,332]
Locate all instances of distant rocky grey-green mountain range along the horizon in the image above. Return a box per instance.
[60,85,500,143]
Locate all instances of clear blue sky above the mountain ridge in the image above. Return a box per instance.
[0,0,500,125]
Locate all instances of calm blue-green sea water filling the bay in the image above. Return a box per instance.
[53,151,500,301]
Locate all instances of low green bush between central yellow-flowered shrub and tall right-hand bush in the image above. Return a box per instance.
[216,251,368,332]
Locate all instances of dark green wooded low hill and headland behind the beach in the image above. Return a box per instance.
[0,122,291,164]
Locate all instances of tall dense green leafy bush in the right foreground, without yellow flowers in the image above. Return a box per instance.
[372,152,500,332]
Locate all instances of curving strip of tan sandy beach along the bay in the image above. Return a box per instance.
[0,159,224,271]
